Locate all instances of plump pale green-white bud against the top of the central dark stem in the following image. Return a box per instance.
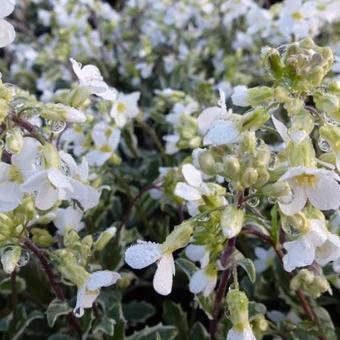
[220,205,244,238]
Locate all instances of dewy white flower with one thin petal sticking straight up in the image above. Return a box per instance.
[197,91,240,145]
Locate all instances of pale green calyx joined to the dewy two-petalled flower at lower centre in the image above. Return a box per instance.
[163,221,193,253]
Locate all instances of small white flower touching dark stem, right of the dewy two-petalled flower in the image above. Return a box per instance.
[189,267,217,296]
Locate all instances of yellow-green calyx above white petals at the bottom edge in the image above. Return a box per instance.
[227,289,249,331]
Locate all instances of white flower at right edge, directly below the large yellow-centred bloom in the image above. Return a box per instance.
[283,219,340,272]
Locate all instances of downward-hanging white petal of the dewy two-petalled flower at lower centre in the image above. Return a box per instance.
[153,254,175,295]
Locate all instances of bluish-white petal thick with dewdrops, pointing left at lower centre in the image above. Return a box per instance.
[125,241,162,269]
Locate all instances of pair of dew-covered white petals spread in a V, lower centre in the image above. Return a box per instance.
[125,240,175,295]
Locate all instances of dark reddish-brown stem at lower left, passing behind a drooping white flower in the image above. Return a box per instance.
[24,237,82,339]
